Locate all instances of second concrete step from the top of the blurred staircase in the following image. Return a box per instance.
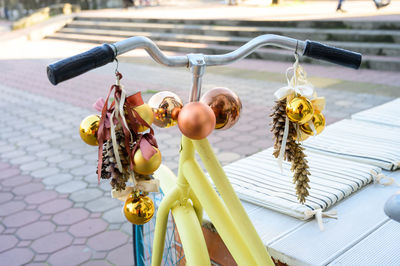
[67,20,400,43]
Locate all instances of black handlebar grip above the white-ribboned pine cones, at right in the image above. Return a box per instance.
[304,40,362,69]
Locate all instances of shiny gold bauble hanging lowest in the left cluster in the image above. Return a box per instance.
[123,194,154,225]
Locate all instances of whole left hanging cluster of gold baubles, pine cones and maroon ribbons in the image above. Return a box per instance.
[79,72,161,224]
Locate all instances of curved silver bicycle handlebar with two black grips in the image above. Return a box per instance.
[47,34,361,85]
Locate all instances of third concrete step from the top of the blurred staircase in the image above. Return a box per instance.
[59,28,400,56]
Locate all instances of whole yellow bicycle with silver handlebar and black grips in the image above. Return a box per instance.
[47,34,361,265]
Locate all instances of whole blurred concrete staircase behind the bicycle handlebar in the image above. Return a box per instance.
[47,16,400,71]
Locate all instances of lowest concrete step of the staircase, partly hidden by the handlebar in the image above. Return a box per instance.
[48,33,400,71]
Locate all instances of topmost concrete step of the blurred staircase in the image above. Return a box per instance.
[76,15,400,30]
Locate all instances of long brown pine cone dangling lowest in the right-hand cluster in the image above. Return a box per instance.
[290,143,310,204]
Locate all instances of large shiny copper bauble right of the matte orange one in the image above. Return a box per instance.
[200,88,242,129]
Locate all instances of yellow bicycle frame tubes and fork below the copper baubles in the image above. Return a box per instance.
[152,136,274,266]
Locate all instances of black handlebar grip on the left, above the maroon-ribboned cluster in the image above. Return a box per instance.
[47,44,115,85]
